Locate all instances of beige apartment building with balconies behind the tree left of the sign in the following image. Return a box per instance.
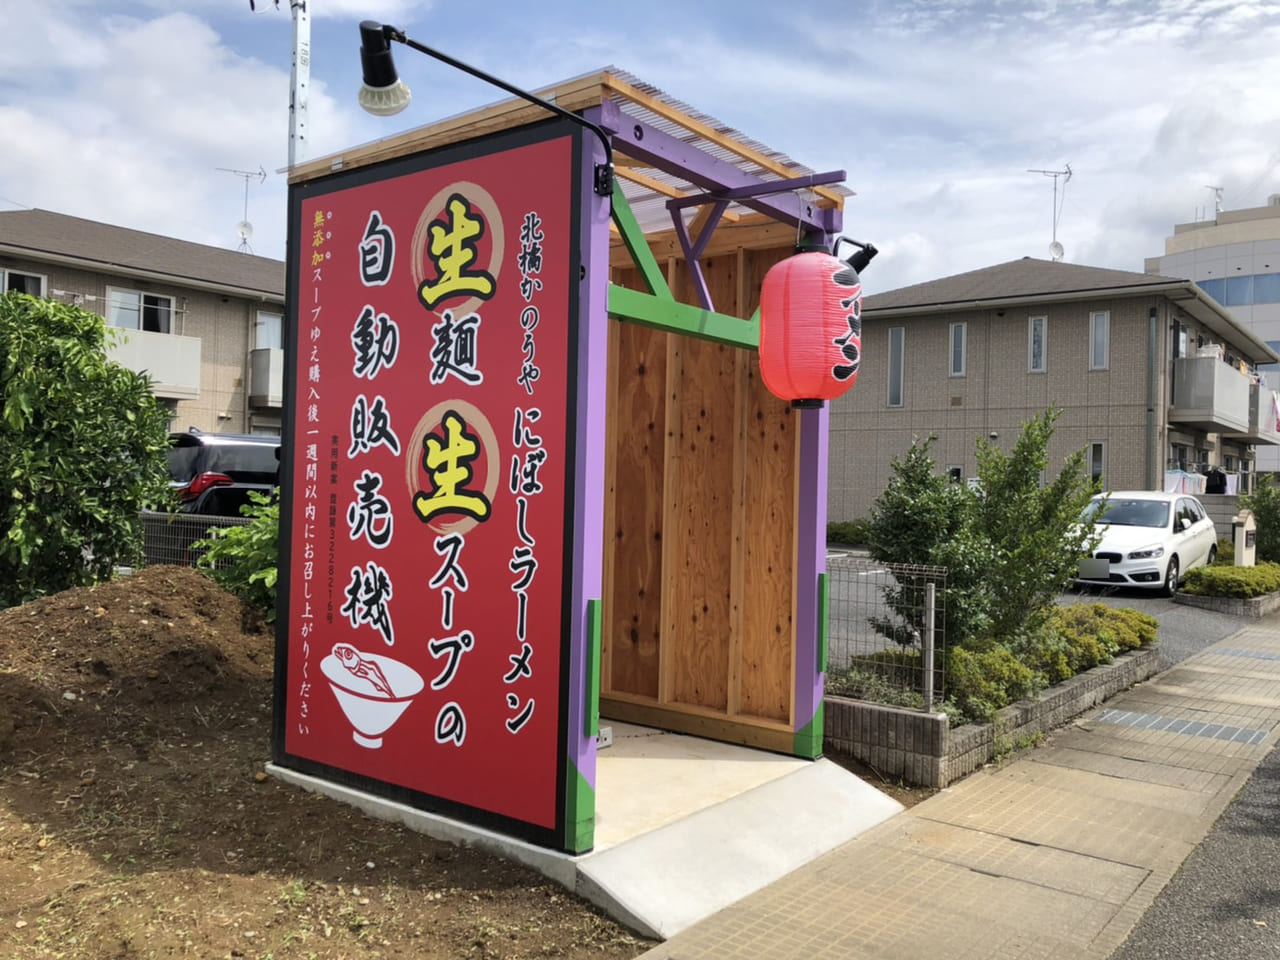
[0,210,284,434]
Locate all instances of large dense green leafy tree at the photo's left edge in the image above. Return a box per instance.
[0,293,169,607]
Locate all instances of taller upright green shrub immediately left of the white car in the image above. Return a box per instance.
[974,408,1100,637]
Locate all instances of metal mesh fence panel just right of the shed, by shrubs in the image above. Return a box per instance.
[827,557,947,710]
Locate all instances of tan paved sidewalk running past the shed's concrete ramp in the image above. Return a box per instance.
[645,617,1280,960]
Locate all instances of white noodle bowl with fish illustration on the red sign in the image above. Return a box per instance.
[320,644,425,750]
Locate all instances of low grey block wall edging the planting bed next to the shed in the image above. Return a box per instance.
[823,648,1160,787]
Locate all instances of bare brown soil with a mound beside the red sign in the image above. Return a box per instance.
[0,566,932,960]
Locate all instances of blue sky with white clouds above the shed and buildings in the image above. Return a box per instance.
[0,0,1280,292]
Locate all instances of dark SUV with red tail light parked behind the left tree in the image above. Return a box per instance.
[166,428,280,517]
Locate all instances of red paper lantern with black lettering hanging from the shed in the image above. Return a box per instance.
[760,252,863,407]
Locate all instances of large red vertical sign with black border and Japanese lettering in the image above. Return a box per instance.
[275,124,580,845]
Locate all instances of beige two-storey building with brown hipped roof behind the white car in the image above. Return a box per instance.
[828,257,1280,521]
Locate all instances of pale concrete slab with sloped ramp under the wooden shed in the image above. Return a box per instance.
[268,721,902,940]
